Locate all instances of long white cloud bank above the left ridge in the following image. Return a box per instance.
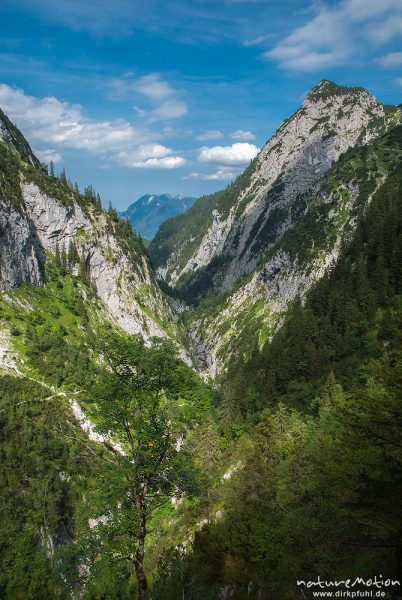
[0,84,185,168]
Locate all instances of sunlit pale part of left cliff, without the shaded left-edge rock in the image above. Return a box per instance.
[18,183,181,338]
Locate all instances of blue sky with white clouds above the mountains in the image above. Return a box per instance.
[0,0,402,210]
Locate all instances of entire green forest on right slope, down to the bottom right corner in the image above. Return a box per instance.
[149,128,402,600]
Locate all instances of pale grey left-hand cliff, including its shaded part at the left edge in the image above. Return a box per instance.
[0,173,184,356]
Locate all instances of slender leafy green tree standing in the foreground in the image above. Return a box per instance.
[81,331,212,599]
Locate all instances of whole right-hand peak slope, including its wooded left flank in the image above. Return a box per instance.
[150,81,401,302]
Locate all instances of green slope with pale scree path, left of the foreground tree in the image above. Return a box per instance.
[0,255,214,600]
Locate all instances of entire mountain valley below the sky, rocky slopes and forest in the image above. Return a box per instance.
[0,80,402,600]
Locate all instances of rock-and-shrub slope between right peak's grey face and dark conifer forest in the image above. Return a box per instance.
[188,126,402,376]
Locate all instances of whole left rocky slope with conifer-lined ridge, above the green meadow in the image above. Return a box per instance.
[0,117,185,350]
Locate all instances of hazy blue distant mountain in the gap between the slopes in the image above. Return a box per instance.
[120,194,196,240]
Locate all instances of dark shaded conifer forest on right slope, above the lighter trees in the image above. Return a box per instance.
[243,140,402,400]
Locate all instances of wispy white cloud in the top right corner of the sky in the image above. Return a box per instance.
[263,0,402,71]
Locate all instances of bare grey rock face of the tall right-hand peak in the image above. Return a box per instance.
[158,81,396,291]
